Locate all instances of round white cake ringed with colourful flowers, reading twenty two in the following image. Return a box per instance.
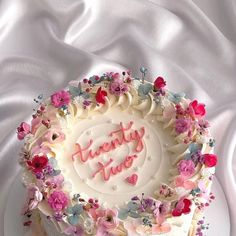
[17,67,217,236]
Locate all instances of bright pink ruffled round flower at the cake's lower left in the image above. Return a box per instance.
[48,190,69,212]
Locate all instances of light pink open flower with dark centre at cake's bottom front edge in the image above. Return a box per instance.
[97,209,119,235]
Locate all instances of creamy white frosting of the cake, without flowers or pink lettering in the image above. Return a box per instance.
[19,75,214,236]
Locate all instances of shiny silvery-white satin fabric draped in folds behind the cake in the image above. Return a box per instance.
[0,0,236,236]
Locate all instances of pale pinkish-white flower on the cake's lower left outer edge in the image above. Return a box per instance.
[22,185,43,214]
